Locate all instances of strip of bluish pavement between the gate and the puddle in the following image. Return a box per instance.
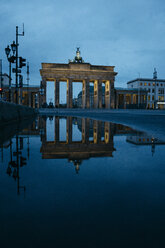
[39,109,165,141]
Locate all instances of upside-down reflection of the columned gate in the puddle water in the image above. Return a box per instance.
[40,117,115,172]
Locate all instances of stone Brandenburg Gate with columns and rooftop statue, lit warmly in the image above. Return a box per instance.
[40,48,117,109]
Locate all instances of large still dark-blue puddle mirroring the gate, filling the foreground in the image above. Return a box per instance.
[0,118,165,248]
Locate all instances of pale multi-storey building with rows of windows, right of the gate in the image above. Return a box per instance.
[127,69,165,109]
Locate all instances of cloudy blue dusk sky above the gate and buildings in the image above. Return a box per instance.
[0,0,165,101]
